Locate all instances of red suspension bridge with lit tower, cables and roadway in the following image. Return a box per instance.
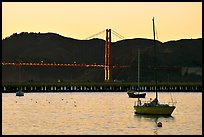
[2,29,180,81]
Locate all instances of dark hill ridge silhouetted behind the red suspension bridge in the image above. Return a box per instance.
[2,32,202,81]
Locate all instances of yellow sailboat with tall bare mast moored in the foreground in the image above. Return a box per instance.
[133,18,176,115]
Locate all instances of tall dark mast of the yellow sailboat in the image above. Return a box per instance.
[152,17,158,100]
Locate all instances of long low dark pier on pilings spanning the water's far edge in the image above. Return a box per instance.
[2,82,203,93]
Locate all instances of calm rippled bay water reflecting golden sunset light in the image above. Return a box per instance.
[2,92,202,135]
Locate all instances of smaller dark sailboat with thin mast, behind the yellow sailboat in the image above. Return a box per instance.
[127,49,146,98]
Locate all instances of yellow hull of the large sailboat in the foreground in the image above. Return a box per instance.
[134,106,175,115]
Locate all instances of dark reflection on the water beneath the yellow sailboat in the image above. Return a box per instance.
[134,114,174,135]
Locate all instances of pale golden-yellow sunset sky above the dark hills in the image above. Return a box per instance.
[2,2,202,42]
